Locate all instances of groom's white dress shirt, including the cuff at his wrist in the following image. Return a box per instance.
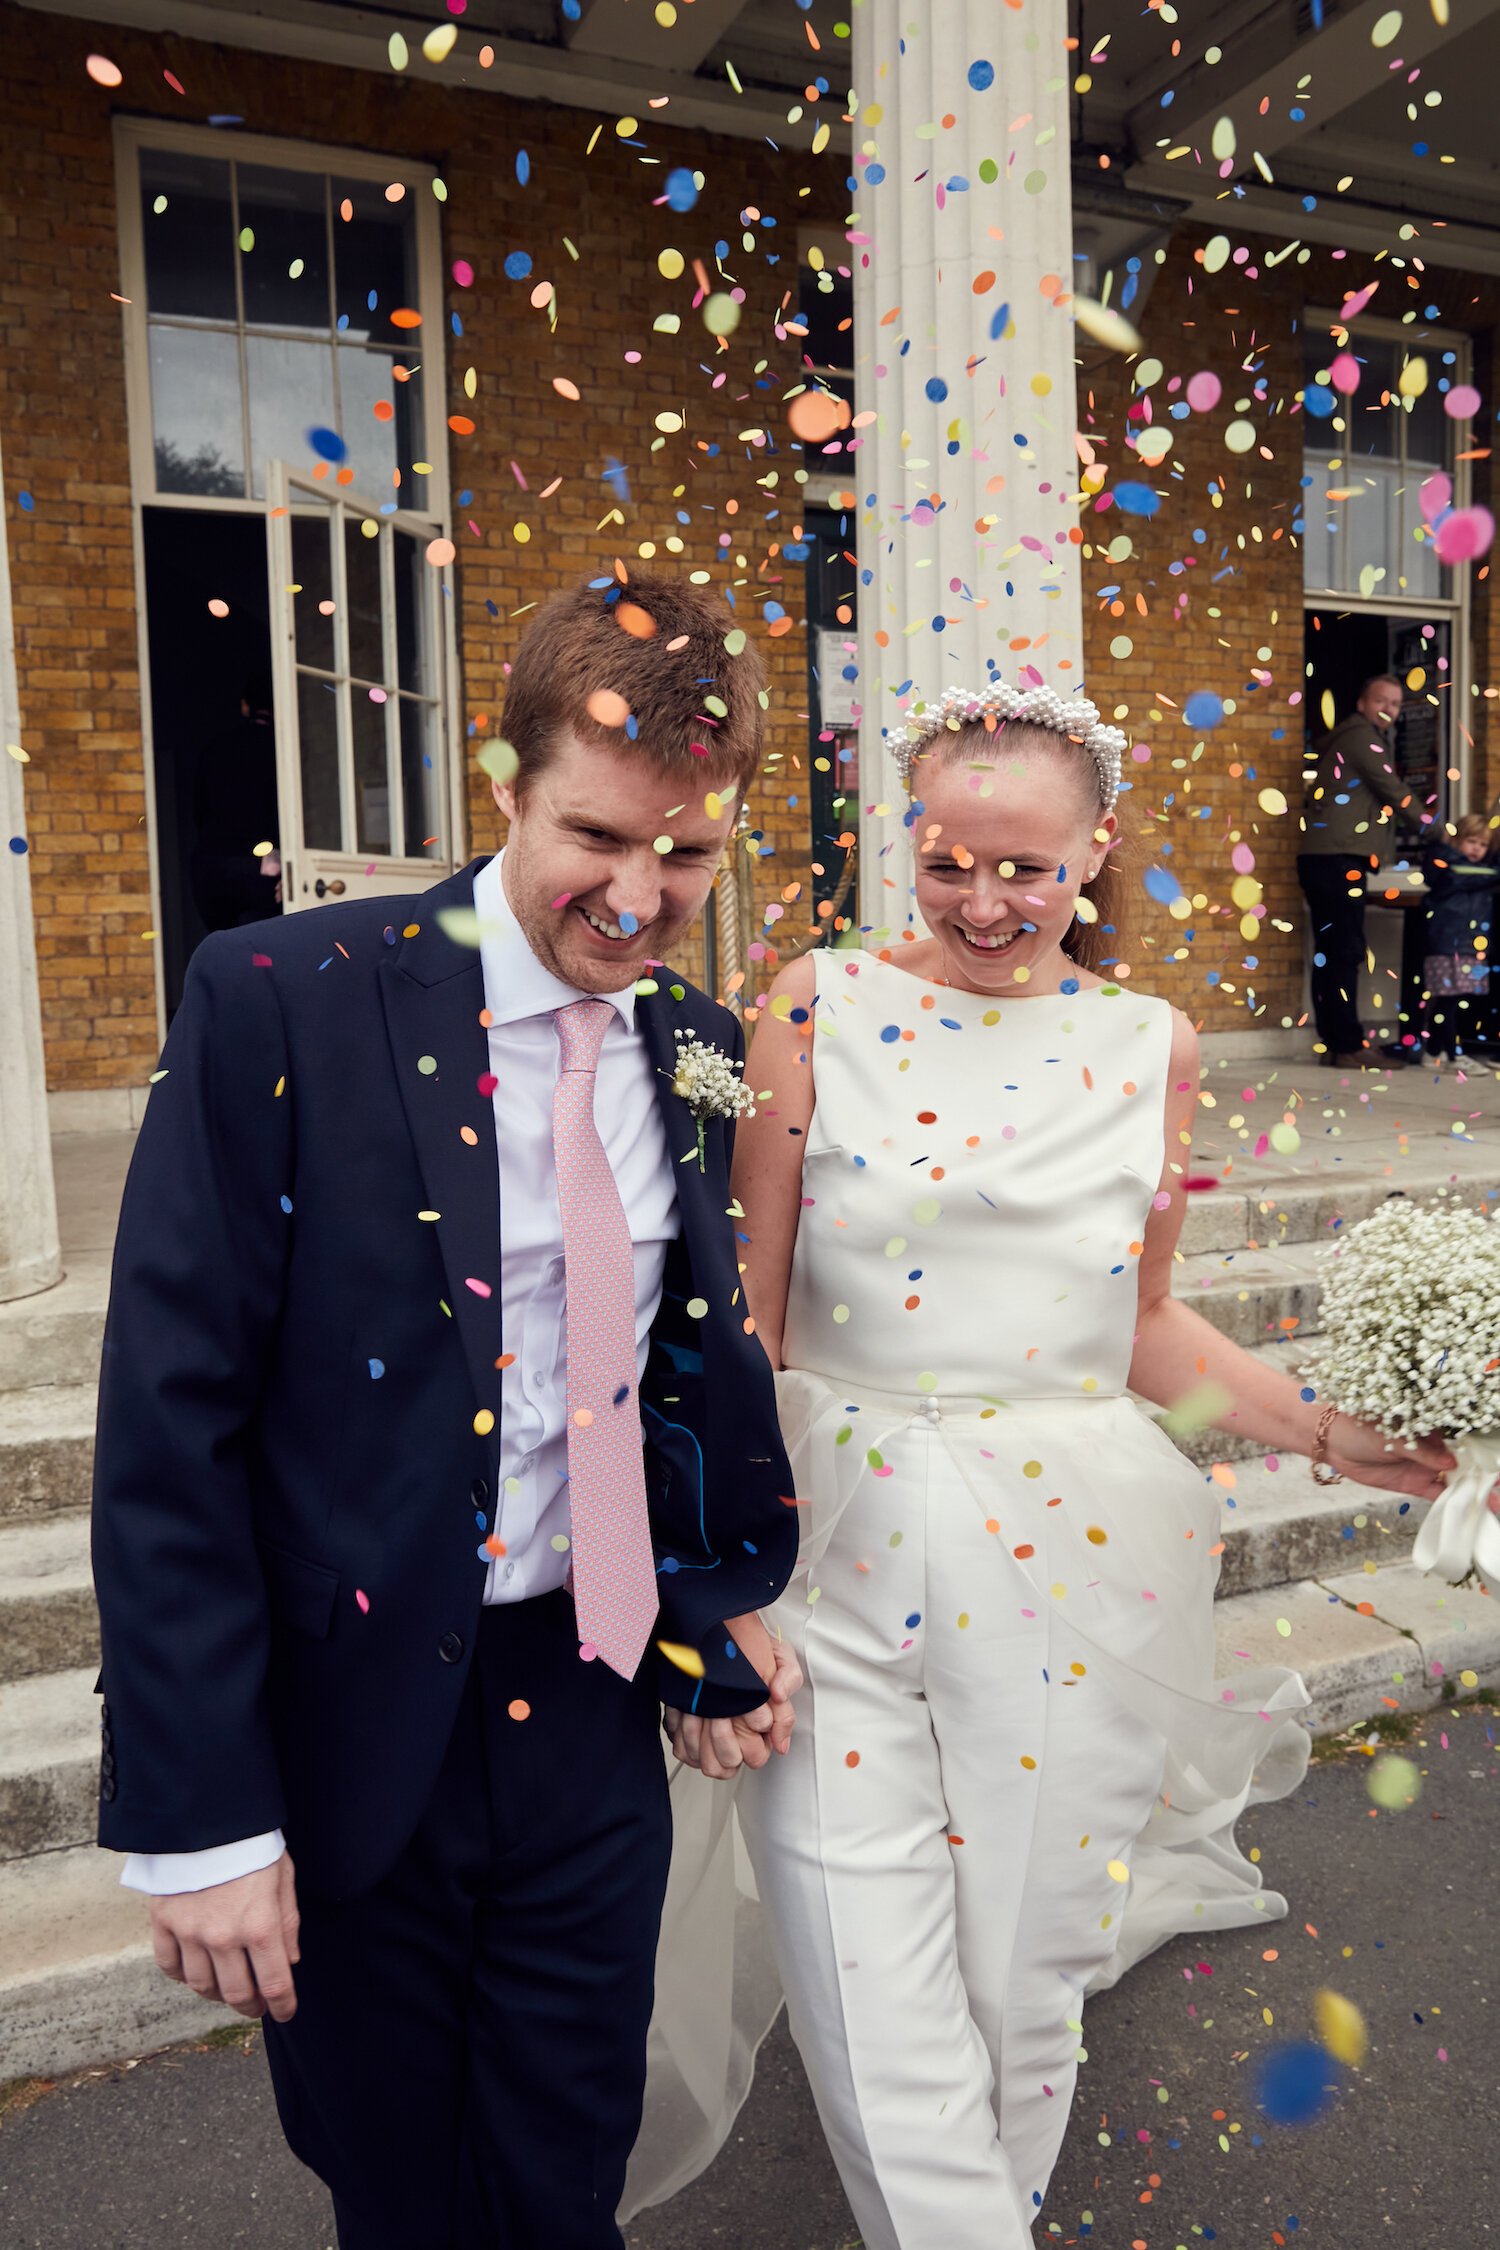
[119,851,681,1897]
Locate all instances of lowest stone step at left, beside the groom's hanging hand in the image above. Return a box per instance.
[0,1845,241,2081]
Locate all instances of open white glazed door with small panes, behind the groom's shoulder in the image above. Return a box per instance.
[265,461,461,914]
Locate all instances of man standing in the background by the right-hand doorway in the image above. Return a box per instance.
[1298,673,1408,1071]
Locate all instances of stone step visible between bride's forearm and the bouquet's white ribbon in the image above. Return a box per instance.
[1214,1454,1428,1602]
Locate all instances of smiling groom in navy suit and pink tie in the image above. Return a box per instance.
[94,578,796,2250]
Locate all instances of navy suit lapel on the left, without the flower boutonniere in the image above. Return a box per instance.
[380,860,504,1451]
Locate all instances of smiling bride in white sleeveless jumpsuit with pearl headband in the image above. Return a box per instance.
[675,684,1451,2250]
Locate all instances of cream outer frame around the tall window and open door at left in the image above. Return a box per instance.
[115,117,468,1042]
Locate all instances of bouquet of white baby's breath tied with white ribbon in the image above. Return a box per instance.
[1304,1195,1500,1591]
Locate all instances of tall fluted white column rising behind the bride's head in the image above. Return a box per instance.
[848,0,1082,932]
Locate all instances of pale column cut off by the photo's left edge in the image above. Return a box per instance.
[0,434,63,1303]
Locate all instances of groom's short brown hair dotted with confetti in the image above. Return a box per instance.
[501,572,769,797]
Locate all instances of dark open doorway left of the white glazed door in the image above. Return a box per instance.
[142,509,279,1019]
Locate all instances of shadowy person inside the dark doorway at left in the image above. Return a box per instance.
[191,671,281,929]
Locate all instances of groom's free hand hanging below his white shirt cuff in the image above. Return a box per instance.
[151,1852,301,2023]
